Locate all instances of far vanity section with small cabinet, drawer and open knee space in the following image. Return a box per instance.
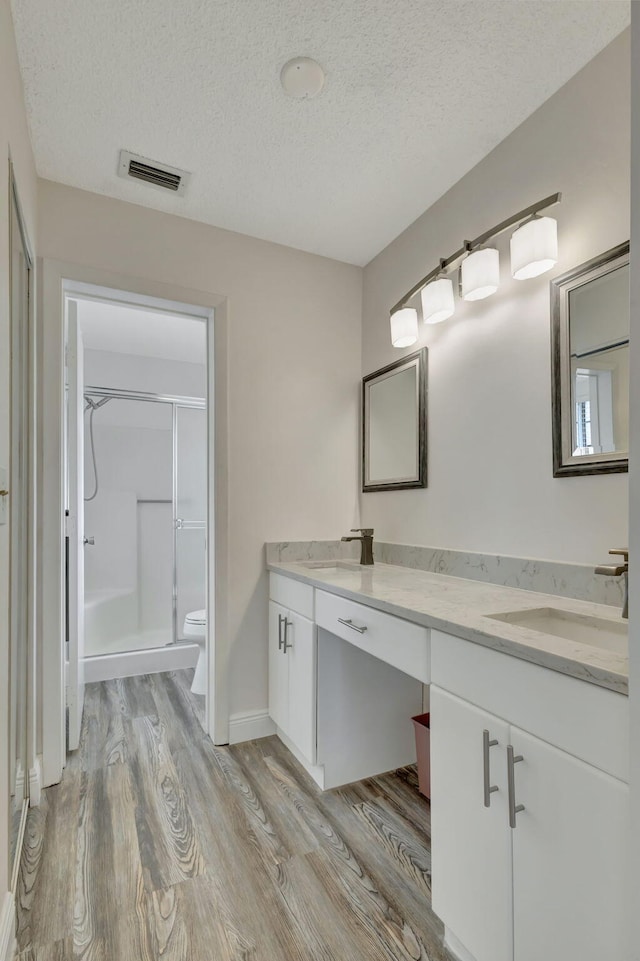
[269,573,429,790]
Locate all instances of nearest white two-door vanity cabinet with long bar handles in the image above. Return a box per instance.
[431,631,628,961]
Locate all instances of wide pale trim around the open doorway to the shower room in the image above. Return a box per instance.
[38,259,229,786]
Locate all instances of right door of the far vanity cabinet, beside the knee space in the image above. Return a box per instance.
[286,611,317,764]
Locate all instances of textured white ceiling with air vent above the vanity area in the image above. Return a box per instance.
[12,0,629,264]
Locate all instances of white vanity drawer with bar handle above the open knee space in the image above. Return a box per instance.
[316,591,430,684]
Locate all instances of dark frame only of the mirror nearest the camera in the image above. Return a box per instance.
[550,241,629,477]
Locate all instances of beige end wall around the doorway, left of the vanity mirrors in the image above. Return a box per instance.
[39,181,362,714]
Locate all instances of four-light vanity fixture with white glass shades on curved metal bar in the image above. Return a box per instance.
[390,193,562,347]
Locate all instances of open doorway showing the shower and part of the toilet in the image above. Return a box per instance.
[64,285,212,750]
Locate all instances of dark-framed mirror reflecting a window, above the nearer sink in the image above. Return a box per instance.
[551,243,630,477]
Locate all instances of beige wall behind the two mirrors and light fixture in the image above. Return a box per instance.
[362,32,630,563]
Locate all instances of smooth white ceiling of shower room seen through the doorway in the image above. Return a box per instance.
[78,300,207,364]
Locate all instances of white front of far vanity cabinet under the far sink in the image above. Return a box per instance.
[269,575,317,764]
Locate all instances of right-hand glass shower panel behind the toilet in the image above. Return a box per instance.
[174,405,207,641]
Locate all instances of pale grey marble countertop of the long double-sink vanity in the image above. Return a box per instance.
[267,562,629,694]
